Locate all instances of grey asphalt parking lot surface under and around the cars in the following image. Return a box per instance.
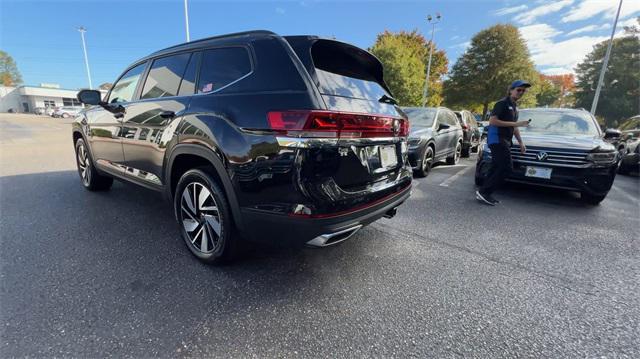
[0,114,640,358]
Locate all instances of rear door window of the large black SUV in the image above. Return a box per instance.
[140,53,191,99]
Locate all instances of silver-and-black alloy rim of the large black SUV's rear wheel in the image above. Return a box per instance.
[180,182,222,253]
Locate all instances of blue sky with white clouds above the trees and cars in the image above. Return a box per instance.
[0,0,640,89]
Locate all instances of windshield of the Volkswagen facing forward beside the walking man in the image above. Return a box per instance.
[519,110,600,136]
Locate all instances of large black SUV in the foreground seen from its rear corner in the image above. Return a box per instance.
[73,31,411,263]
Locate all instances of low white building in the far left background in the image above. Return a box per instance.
[0,84,82,113]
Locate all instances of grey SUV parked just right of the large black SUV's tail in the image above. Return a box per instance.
[403,107,463,177]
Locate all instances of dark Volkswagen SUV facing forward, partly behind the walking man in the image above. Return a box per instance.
[475,108,618,204]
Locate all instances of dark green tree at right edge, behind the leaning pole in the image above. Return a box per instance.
[576,29,640,127]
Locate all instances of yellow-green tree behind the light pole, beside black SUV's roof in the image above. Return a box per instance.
[369,30,448,106]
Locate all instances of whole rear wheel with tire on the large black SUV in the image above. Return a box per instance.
[173,168,238,264]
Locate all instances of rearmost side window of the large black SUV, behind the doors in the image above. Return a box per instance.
[198,47,251,93]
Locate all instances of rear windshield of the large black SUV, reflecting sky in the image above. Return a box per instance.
[311,40,390,101]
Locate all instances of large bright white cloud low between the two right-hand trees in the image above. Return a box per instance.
[520,24,608,73]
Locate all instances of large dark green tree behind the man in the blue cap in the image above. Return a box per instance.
[443,25,539,116]
